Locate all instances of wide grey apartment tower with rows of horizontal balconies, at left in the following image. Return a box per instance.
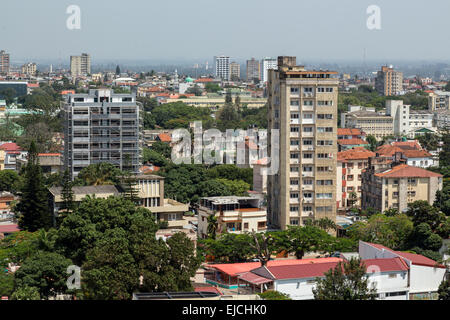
[64,89,142,178]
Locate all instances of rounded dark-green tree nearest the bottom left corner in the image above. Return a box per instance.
[15,251,72,297]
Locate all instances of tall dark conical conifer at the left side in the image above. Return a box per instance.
[16,141,52,232]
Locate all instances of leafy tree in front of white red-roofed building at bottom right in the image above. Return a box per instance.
[313,258,377,300]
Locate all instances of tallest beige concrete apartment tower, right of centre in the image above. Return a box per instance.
[267,56,339,229]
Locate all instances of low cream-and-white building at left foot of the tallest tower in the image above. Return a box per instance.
[198,196,267,238]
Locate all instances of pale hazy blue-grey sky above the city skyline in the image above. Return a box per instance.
[0,0,450,63]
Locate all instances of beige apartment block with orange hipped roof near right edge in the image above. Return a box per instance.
[361,158,442,212]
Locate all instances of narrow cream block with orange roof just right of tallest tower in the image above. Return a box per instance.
[336,147,375,209]
